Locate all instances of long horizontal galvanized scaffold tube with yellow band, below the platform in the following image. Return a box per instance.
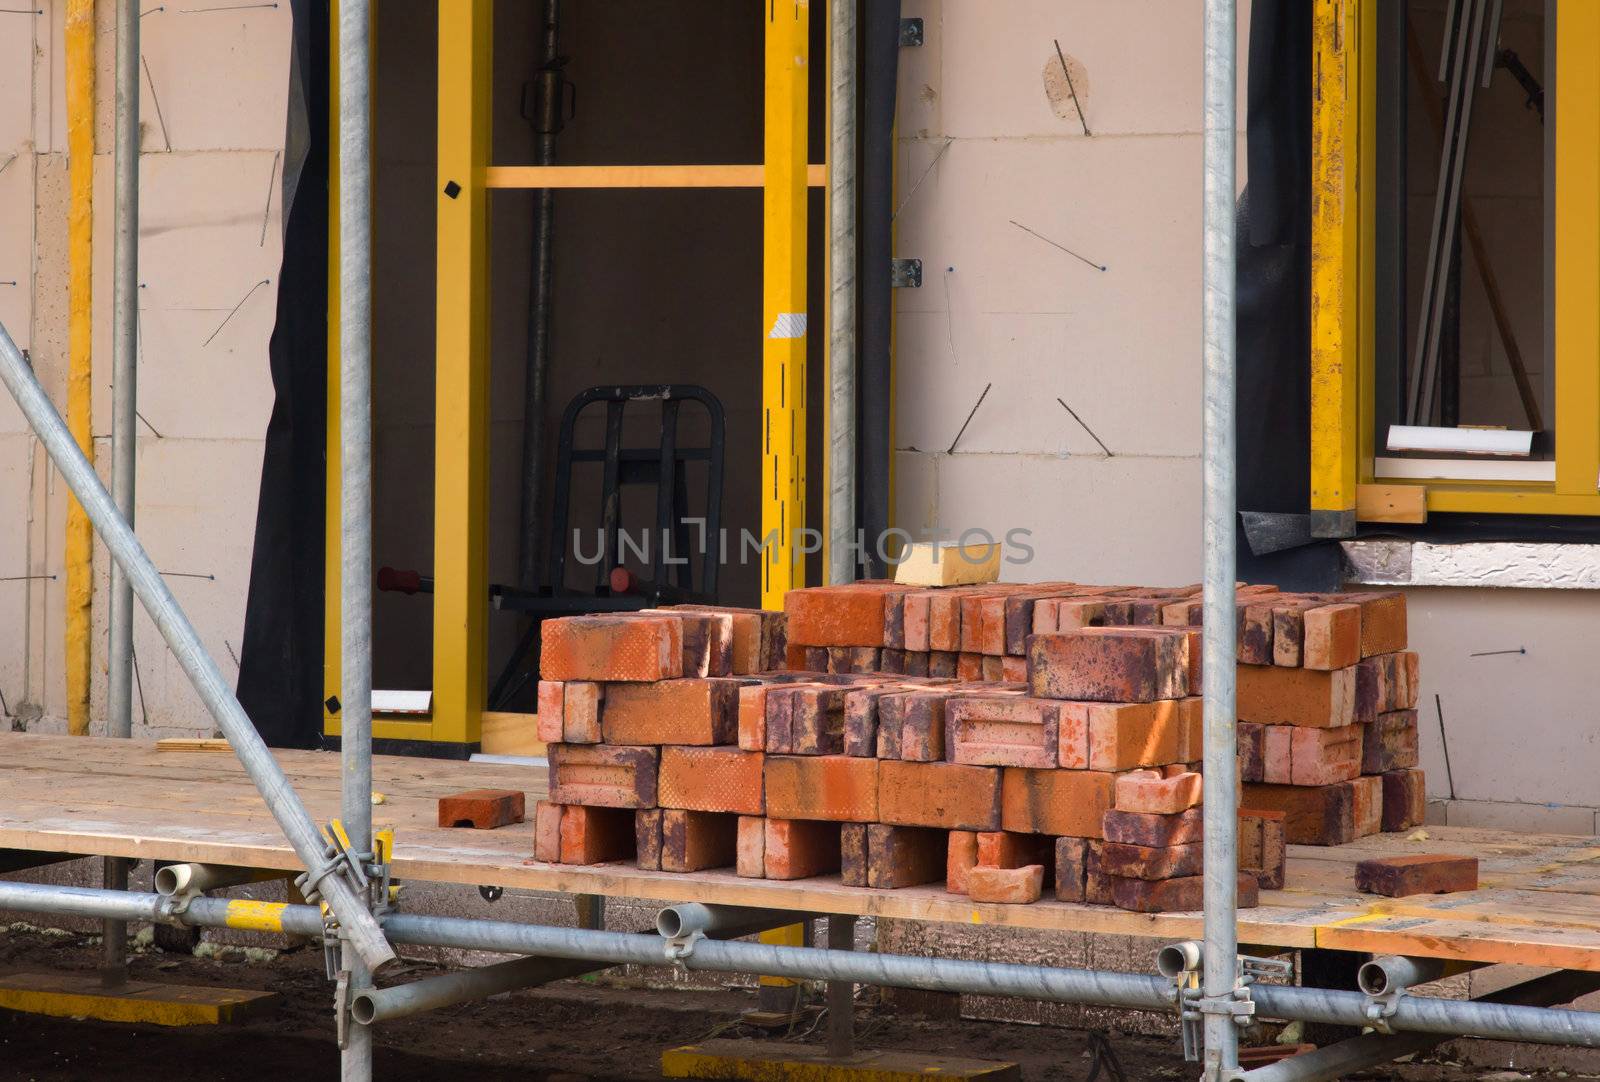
[0,882,1600,1048]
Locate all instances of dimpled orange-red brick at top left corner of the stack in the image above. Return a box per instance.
[539,616,683,680]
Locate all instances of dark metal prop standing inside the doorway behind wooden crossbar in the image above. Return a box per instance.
[517,0,565,595]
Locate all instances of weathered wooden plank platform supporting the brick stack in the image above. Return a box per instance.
[0,733,1600,972]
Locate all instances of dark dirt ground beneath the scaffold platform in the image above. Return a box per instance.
[0,932,1576,1082]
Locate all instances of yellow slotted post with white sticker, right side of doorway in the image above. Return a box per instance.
[760,0,811,608]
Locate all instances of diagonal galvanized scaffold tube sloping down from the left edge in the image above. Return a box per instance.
[0,325,395,968]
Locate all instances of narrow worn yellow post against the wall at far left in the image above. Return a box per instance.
[64,0,94,736]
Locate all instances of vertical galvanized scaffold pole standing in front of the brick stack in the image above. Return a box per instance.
[1202,0,1238,1082]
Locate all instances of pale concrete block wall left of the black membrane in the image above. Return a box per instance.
[0,0,291,736]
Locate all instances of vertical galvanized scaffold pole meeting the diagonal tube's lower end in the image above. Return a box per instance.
[339,0,373,1082]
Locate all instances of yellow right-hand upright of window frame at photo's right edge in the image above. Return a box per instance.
[1554,3,1600,498]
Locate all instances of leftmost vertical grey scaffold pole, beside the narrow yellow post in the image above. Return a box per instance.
[101,0,139,984]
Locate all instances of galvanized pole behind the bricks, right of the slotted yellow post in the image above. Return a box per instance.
[827,0,858,584]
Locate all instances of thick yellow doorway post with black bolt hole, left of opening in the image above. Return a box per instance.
[432,0,494,744]
